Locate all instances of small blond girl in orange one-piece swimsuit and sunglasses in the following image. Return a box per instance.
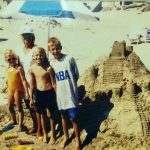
[4,50,29,131]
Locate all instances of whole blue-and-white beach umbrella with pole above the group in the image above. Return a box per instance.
[0,0,99,54]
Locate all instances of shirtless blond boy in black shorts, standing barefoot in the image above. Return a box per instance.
[29,47,57,144]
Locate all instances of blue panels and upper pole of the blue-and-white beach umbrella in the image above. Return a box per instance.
[19,0,75,42]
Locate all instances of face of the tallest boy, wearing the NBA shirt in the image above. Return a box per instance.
[48,42,61,59]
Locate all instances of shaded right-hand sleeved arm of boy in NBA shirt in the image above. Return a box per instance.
[69,57,79,81]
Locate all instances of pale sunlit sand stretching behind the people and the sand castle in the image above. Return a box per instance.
[0,9,150,74]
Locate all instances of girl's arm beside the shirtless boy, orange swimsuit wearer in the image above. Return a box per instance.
[18,67,29,99]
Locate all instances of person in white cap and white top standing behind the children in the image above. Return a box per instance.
[16,26,37,134]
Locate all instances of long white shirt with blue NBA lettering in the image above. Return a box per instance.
[50,54,79,110]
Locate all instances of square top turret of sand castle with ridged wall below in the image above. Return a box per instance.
[103,42,125,84]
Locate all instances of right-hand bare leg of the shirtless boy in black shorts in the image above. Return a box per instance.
[47,109,56,144]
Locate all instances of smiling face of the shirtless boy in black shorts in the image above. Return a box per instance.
[33,49,45,65]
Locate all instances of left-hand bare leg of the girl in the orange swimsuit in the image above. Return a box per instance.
[8,95,17,124]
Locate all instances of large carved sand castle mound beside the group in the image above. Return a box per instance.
[79,41,150,137]
